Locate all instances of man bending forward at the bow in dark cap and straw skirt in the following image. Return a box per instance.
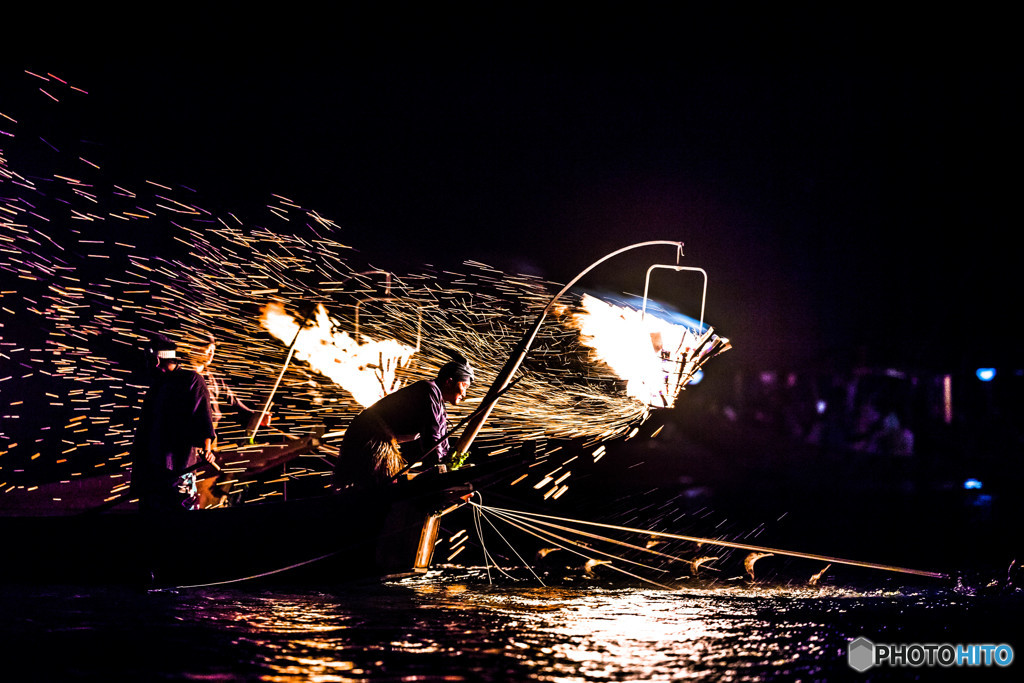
[335,353,473,487]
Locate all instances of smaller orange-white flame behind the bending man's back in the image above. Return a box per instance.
[260,303,417,408]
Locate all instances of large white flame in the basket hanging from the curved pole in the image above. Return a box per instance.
[571,294,729,408]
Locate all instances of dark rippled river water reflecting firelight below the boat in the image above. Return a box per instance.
[0,568,1022,682]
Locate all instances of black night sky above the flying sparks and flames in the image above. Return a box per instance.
[5,10,1021,369]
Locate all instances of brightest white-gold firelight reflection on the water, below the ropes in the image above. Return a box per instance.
[397,588,856,681]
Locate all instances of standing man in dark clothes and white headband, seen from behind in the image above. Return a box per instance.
[131,337,216,510]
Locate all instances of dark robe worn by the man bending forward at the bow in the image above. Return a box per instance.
[337,380,449,483]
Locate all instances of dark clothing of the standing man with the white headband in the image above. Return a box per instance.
[131,366,214,507]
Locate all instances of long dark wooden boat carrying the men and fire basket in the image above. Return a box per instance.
[0,463,499,587]
